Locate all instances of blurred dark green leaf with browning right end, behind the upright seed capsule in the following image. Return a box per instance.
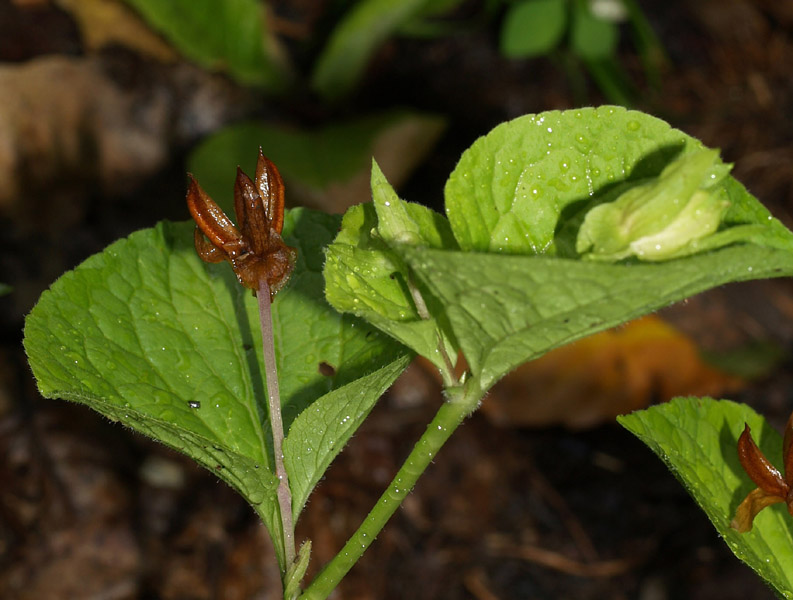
[189,111,444,214]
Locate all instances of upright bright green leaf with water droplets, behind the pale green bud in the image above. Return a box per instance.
[445,106,793,257]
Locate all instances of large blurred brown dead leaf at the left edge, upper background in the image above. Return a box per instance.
[0,55,249,227]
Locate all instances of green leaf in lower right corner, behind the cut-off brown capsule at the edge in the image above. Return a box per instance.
[617,398,793,598]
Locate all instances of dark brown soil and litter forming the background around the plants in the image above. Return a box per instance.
[0,0,793,600]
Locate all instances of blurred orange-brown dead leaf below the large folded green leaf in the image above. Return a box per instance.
[482,316,743,429]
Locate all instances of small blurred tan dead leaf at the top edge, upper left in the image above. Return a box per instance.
[55,0,178,62]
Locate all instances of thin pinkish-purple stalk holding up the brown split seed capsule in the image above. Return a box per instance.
[256,278,295,574]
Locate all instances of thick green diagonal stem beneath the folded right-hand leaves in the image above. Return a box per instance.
[299,380,483,600]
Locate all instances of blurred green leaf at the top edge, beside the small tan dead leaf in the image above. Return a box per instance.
[125,0,286,92]
